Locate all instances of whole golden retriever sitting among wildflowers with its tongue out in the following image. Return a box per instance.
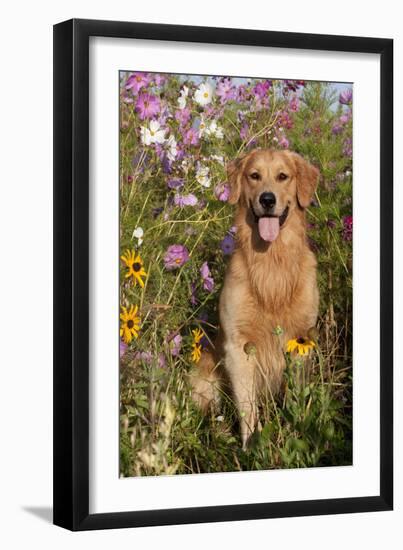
[190,149,319,448]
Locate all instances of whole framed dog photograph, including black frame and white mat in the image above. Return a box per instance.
[54,20,393,530]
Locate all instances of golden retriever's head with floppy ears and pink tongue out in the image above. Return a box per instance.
[227,149,319,242]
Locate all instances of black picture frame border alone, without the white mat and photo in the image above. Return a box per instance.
[54,19,393,530]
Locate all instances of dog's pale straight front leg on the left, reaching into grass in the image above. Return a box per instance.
[225,344,257,450]
